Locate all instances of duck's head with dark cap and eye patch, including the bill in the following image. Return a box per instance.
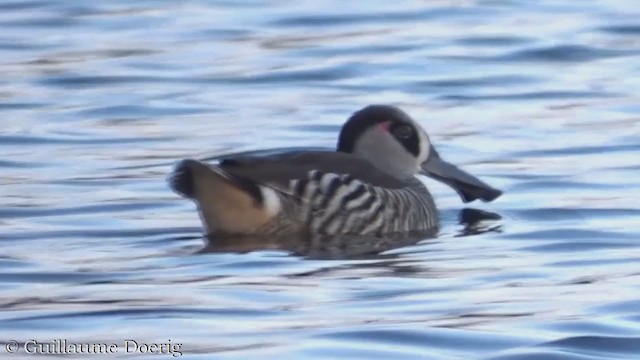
[337,105,502,202]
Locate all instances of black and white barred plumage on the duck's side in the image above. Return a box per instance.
[281,171,438,235]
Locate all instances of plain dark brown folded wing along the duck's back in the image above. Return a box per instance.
[218,150,406,188]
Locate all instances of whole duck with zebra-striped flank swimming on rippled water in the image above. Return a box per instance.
[169,105,502,237]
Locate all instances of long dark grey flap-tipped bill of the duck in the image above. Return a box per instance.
[422,149,502,203]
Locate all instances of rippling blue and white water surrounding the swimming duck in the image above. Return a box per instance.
[0,0,640,360]
